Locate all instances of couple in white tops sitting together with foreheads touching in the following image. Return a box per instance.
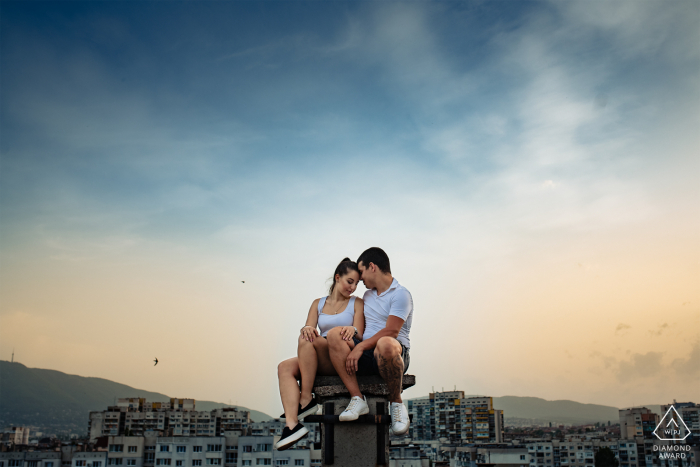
[275,248,413,451]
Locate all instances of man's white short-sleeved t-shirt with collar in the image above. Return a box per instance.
[362,279,413,349]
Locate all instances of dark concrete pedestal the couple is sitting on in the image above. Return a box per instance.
[307,375,416,467]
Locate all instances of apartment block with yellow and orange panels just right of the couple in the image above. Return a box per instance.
[408,391,504,443]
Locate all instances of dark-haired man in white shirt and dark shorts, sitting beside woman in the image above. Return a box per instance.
[328,247,413,435]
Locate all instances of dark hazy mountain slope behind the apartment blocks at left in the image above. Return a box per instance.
[0,360,272,436]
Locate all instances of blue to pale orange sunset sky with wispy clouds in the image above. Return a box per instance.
[0,0,700,416]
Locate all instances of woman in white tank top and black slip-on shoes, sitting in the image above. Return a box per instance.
[275,258,365,451]
